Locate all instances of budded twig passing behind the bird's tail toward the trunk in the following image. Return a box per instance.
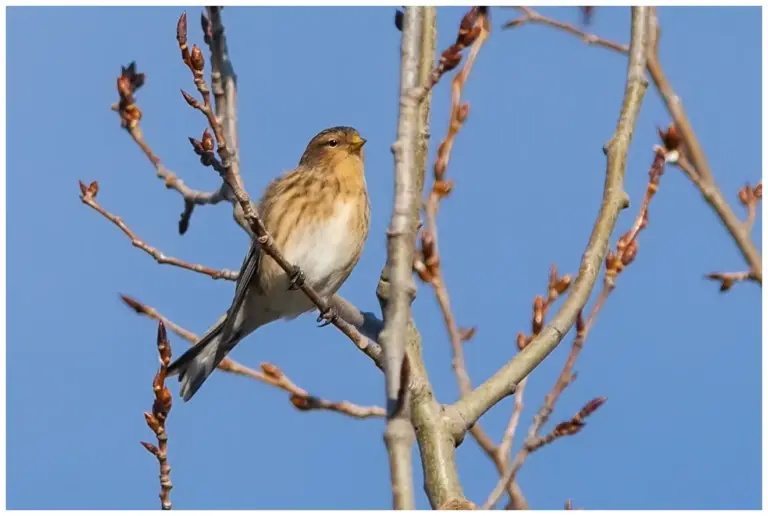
[120,294,385,419]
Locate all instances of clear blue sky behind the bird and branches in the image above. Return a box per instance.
[7,7,762,509]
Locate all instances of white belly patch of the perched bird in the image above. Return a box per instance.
[285,203,357,296]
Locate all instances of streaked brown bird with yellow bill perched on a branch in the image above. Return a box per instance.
[168,127,370,401]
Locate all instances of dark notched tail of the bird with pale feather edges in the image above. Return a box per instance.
[168,316,240,402]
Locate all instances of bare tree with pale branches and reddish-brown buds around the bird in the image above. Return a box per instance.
[75,7,762,509]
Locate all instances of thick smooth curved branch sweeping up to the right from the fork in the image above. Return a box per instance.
[452,7,649,436]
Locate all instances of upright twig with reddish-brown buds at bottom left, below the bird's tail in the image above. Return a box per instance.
[141,321,173,510]
